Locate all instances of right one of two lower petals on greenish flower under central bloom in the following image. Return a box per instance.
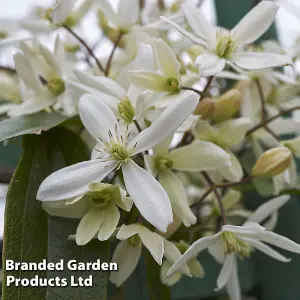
[98,205,120,241]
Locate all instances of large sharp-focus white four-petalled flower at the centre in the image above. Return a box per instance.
[37,92,198,232]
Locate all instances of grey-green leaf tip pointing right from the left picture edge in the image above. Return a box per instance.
[0,112,67,142]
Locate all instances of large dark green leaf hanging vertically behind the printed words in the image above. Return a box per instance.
[3,127,109,300]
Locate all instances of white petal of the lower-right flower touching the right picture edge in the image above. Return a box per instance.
[253,231,300,254]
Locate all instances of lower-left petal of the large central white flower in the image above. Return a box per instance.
[37,160,116,201]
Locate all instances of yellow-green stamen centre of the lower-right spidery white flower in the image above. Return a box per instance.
[221,231,252,257]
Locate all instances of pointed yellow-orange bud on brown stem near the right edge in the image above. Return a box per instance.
[252,147,292,177]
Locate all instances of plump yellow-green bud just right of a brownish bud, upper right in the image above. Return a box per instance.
[213,89,242,122]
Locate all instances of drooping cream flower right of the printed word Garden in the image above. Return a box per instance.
[109,224,164,287]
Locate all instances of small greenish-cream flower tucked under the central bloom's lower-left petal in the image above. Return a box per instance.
[72,182,132,245]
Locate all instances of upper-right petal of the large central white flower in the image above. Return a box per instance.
[128,92,199,154]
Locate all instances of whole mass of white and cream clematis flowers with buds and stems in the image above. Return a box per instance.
[0,0,300,300]
